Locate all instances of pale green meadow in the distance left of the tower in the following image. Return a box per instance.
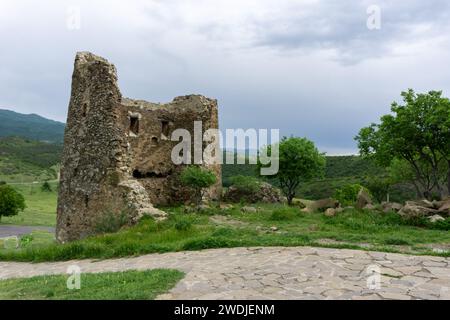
[0,182,57,226]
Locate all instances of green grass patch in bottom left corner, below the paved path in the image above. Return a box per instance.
[0,269,184,300]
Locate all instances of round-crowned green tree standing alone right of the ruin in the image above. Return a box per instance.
[258,137,325,205]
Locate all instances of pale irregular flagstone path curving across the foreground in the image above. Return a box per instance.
[0,247,450,299]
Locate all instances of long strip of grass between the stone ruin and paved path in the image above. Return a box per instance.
[0,205,450,261]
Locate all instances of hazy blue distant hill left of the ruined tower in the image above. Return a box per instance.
[0,109,65,143]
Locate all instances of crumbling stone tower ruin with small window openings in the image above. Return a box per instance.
[56,52,221,242]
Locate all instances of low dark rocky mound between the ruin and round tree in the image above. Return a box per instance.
[224,182,284,203]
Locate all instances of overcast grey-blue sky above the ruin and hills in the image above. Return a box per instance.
[0,0,450,154]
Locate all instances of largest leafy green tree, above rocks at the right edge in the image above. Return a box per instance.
[355,89,450,199]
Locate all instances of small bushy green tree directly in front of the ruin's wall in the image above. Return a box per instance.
[180,166,217,205]
